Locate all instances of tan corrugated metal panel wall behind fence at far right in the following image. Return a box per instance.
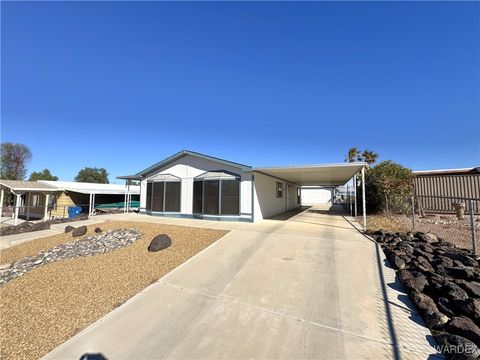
[415,174,480,213]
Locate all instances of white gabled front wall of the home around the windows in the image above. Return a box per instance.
[140,155,252,217]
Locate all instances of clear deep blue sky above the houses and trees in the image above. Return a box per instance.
[1,2,480,181]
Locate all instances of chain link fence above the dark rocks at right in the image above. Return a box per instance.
[384,194,480,253]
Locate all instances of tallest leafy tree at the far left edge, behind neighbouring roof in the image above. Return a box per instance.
[0,143,32,180]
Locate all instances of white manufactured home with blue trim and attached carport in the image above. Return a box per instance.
[118,150,364,222]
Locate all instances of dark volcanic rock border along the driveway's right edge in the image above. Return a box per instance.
[369,230,480,359]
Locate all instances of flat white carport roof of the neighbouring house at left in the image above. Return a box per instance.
[38,180,140,195]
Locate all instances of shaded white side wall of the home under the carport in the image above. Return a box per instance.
[254,172,300,221]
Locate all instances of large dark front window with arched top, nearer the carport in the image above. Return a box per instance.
[193,171,240,215]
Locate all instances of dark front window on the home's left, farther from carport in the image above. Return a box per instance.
[145,181,181,212]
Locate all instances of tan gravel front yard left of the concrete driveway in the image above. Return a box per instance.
[0,221,227,359]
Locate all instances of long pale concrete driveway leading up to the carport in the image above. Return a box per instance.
[46,208,435,359]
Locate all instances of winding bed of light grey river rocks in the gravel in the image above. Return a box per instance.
[0,229,141,286]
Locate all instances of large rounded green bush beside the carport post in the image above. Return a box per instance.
[357,160,413,213]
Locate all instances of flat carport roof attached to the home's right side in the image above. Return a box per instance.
[253,162,366,186]
